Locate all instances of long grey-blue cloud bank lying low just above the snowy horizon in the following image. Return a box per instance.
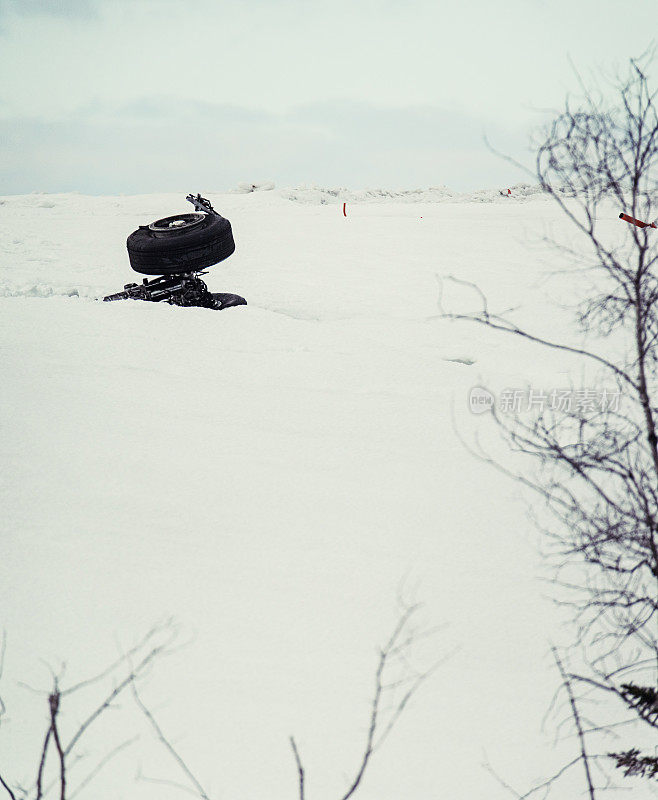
[0,98,525,193]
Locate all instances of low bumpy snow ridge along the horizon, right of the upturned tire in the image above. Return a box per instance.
[277,183,542,205]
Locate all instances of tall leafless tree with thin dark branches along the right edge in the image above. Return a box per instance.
[442,54,658,794]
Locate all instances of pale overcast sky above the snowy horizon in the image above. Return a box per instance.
[0,0,657,194]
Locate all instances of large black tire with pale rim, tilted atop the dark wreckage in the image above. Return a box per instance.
[126,212,235,275]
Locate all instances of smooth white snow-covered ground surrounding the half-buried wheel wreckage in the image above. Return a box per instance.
[0,189,618,800]
